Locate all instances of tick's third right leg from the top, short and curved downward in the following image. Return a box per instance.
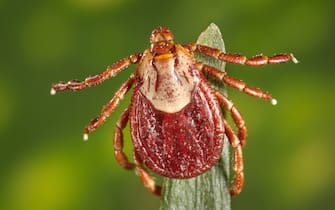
[215,91,248,147]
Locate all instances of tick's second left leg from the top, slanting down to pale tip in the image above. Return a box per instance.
[84,74,135,140]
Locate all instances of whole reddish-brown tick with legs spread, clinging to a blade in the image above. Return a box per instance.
[51,27,297,195]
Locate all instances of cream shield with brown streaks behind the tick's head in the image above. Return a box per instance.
[137,45,199,113]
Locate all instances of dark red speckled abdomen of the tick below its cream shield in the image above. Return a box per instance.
[130,78,224,178]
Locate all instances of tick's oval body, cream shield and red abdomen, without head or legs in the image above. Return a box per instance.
[130,45,224,178]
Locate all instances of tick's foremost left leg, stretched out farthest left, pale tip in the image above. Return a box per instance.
[50,54,142,95]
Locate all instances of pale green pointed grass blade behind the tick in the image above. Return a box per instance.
[160,23,231,210]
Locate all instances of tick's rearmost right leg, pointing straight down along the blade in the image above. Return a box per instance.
[223,120,244,195]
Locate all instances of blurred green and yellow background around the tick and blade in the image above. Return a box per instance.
[0,0,335,210]
